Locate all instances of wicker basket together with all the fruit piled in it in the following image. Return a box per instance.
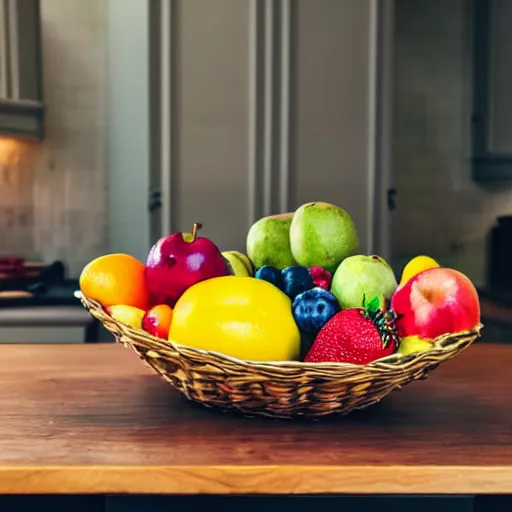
[77,202,483,419]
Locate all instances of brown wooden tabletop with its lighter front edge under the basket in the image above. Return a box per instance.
[0,343,512,494]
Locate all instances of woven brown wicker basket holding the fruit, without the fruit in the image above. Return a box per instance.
[76,292,483,419]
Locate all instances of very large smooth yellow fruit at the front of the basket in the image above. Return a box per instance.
[169,276,300,361]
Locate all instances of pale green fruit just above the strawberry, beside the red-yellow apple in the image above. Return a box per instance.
[331,254,397,309]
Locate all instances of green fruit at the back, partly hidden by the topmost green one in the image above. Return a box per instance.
[246,212,297,270]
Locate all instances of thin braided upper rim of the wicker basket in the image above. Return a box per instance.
[74,290,484,371]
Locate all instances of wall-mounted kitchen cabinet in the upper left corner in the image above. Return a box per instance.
[0,0,44,139]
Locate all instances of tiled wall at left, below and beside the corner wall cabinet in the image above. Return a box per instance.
[0,0,107,276]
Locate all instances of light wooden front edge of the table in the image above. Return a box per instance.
[0,465,512,495]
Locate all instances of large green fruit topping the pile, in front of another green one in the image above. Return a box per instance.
[290,202,359,273]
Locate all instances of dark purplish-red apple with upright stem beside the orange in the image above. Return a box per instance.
[146,224,228,307]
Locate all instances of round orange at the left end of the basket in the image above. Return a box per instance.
[79,253,151,310]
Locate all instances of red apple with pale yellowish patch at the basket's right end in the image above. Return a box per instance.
[391,267,480,339]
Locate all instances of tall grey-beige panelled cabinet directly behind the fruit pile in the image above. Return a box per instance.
[109,0,393,258]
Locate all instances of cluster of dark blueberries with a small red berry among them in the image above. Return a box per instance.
[255,266,341,337]
